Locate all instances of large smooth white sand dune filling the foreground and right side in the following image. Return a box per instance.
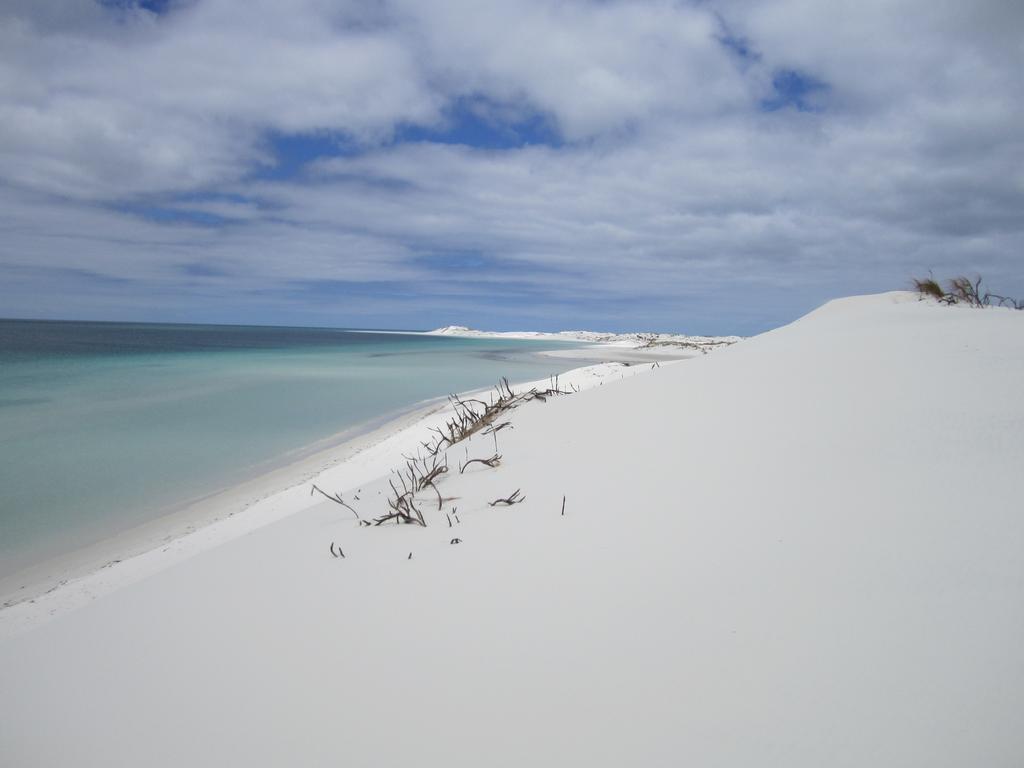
[0,294,1024,766]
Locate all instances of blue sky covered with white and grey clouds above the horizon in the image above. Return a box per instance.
[0,0,1024,335]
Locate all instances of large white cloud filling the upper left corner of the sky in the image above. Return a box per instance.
[0,0,440,199]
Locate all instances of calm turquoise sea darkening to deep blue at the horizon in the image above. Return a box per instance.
[0,321,581,574]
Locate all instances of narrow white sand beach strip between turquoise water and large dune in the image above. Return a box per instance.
[0,360,643,638]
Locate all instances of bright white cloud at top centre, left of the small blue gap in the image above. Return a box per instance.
[387,0,750,139]
